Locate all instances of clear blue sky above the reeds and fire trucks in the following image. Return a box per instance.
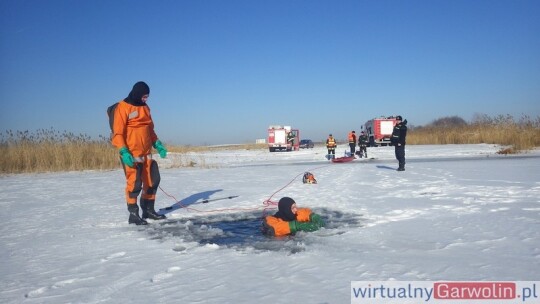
[0,0,540,145]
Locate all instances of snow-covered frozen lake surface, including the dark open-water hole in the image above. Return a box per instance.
[0,144,540,303]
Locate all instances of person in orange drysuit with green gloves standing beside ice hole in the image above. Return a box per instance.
[111,81,167,225]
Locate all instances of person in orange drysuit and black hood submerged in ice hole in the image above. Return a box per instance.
[262,197,324,236]
